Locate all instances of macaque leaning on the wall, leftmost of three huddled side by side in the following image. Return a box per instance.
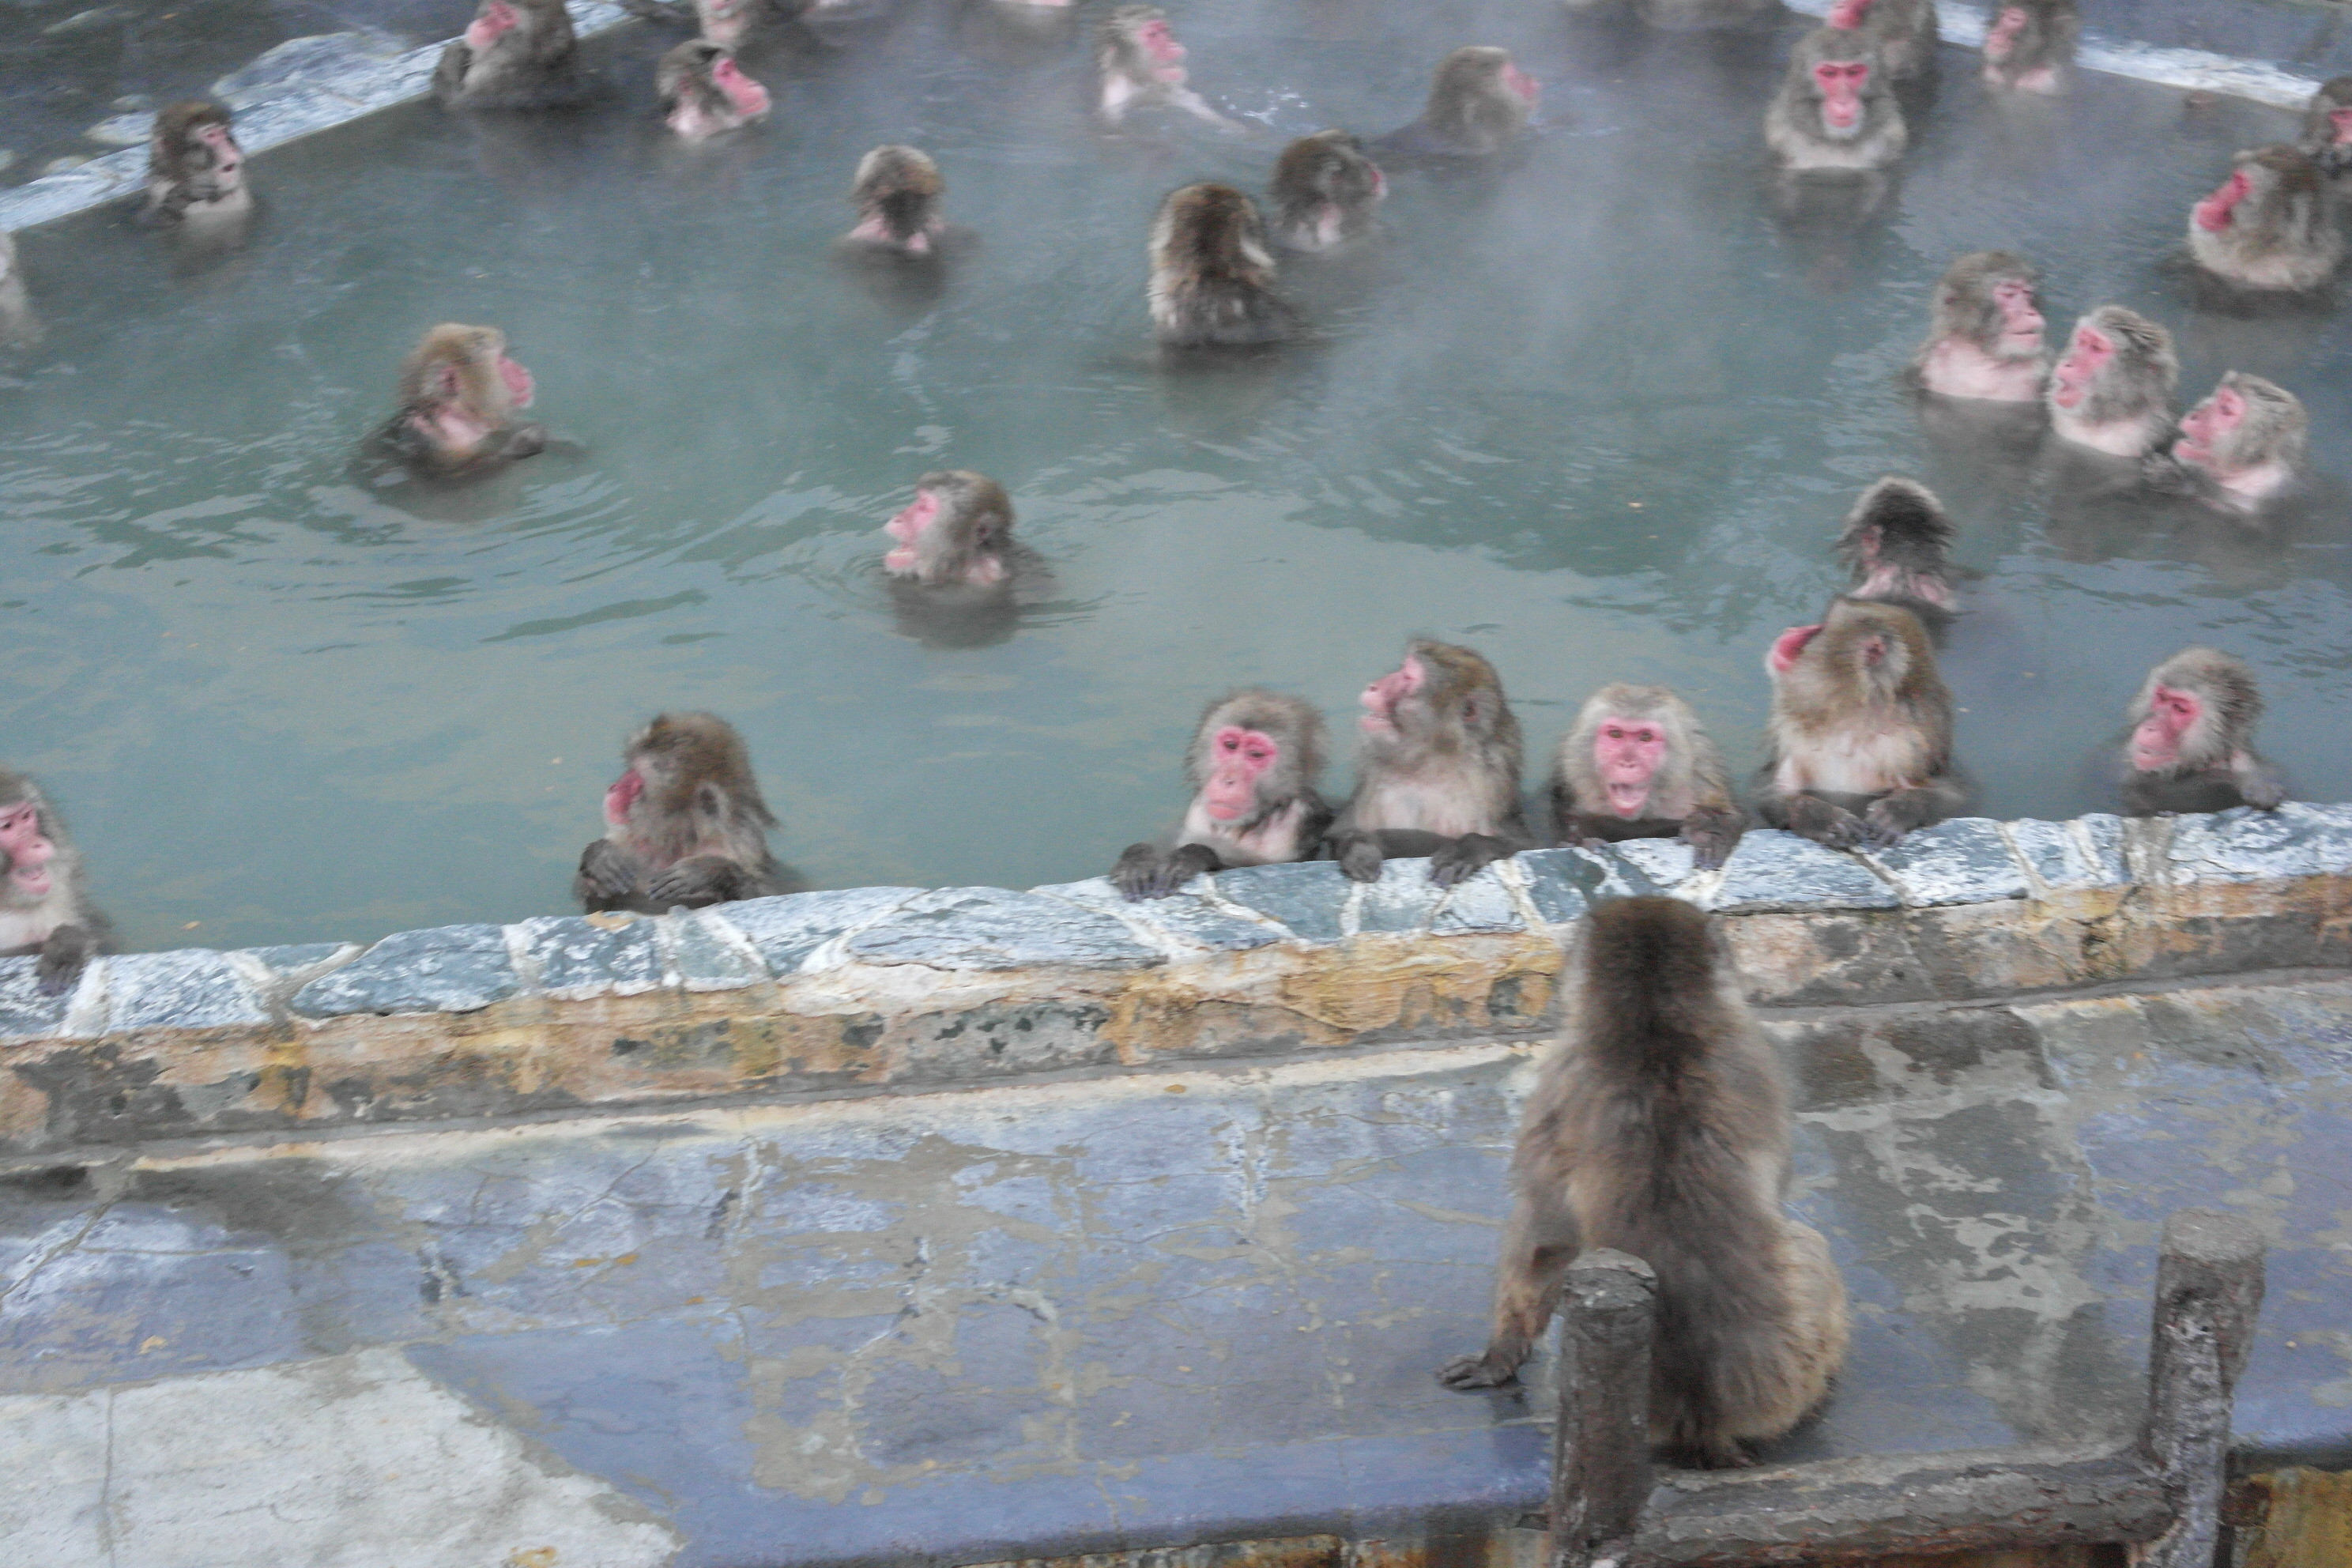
[1110,687,1331,898]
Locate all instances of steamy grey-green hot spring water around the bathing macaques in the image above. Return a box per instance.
[0,0,2352,948]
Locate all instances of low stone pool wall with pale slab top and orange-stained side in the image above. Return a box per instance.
[0,818,2352,1159]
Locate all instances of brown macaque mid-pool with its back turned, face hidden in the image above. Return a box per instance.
[1150,186,1298,348]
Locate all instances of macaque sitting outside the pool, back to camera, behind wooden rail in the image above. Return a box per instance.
[1439,898,1846,1469]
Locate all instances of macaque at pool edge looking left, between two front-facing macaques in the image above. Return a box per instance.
[1331,637,1526,886]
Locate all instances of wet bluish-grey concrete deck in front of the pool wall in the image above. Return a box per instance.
[0,978,2352,1568]
